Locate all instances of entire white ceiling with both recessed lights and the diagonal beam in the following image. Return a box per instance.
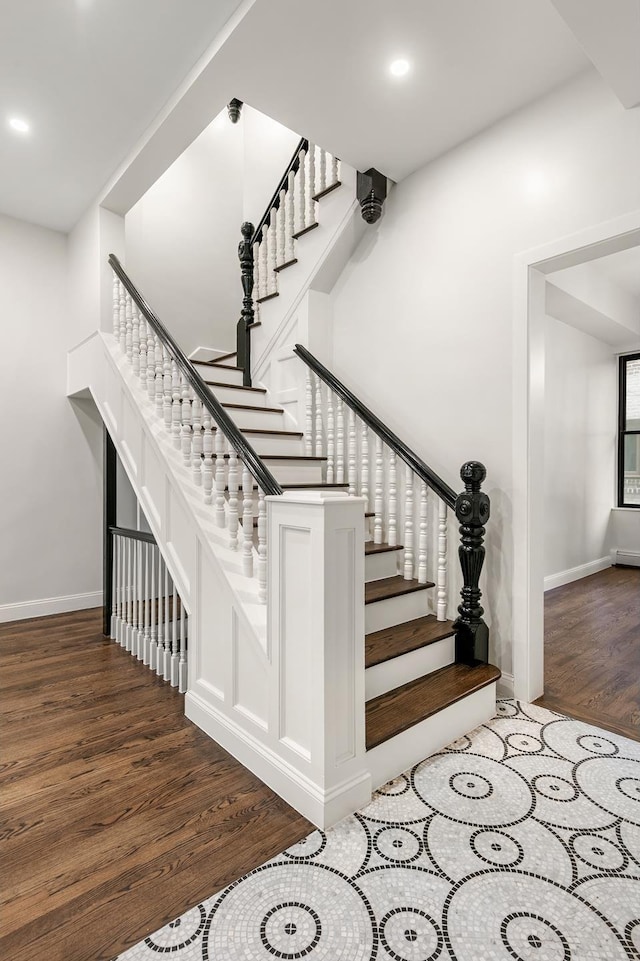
[0,0,638,230]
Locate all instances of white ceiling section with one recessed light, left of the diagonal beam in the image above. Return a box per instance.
[0,0,245,230]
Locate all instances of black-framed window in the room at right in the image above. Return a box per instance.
[618,354,640,508]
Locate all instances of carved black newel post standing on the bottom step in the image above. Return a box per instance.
[453,460,491,664]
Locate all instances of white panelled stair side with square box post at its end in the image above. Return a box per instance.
[67,331,371,827]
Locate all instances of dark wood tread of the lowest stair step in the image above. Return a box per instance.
[366,664,500,751]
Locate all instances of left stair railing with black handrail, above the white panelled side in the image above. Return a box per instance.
[109,254,282,602]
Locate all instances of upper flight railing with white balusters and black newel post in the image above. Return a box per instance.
[236,137,340,387]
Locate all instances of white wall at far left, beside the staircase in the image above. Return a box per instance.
[0,216,102,620]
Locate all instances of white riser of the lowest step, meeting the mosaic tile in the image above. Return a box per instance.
[367,682,496,789]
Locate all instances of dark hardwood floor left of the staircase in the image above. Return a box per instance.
[0,611,312,961]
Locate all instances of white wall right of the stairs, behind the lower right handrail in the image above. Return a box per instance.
[333,72,640,672]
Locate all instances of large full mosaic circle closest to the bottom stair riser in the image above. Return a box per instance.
[413,754,533,827]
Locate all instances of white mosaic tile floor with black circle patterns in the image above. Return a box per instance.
[119,701,640,961]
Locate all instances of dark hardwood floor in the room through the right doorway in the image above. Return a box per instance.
[536,567,640,740]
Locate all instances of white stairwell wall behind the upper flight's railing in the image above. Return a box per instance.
[125,105,299,353]
